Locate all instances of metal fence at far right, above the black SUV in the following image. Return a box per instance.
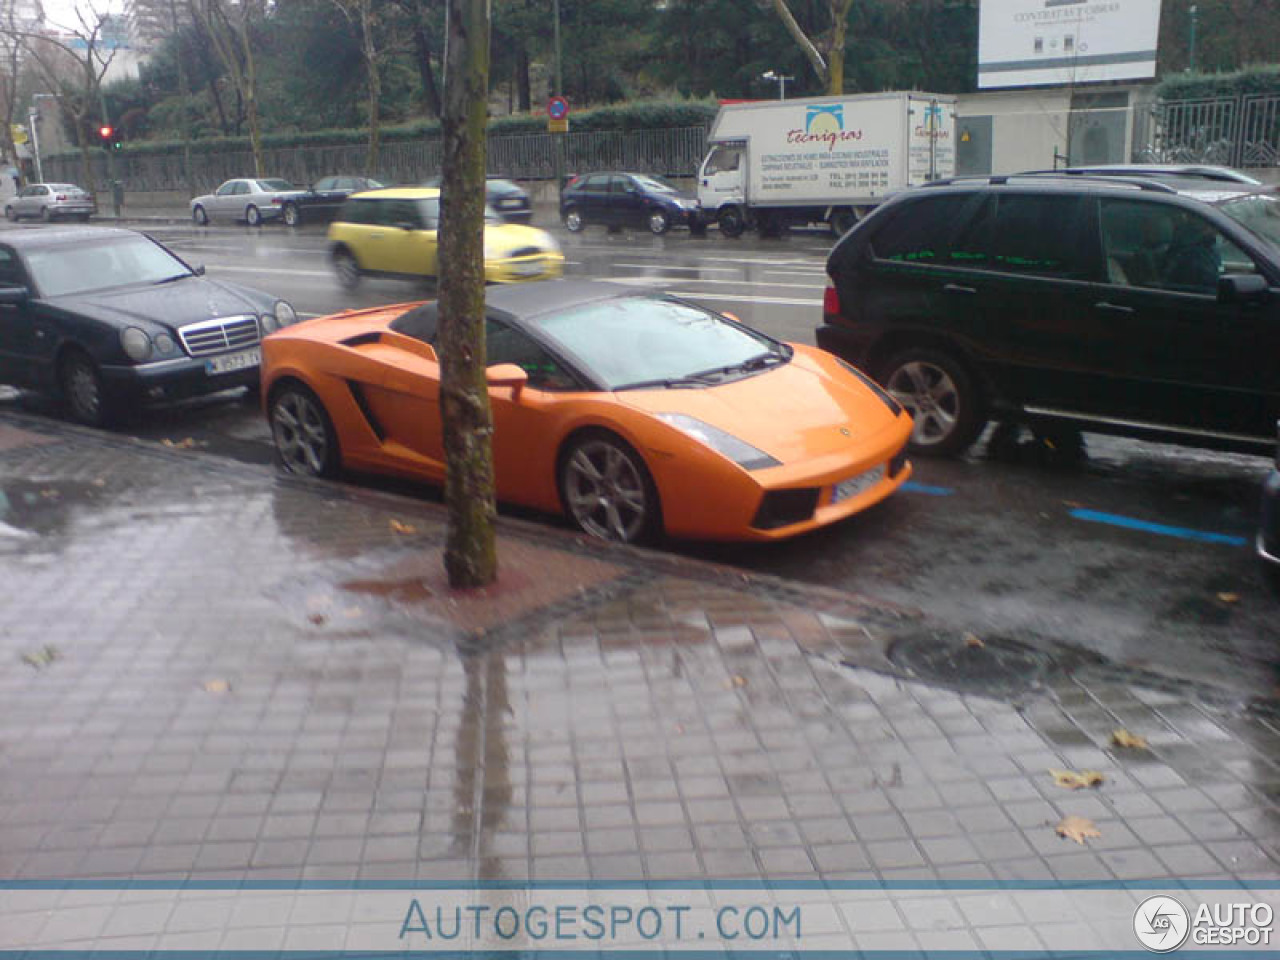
[1135,93,1280,166]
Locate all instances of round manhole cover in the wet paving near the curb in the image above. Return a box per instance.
[888,634,1053,698]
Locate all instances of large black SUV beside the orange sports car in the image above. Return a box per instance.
[818,175,1280,454]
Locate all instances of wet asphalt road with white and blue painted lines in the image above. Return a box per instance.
[0,225,1280,699]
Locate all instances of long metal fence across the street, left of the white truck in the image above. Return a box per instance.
[44,127,707,193]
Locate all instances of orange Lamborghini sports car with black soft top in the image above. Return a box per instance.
[262,280,911,541]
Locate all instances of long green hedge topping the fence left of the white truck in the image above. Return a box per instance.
[47,100,718,163]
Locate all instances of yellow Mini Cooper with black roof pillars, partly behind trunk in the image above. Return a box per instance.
[329,187,564,289]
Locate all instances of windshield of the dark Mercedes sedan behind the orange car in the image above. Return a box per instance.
[27,237,193,297]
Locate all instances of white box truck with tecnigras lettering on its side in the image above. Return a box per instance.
[698,92,956,237]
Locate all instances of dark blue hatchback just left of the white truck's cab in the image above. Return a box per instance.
[561,173,700,234]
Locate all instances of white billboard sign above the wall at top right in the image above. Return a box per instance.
[978,0,1160,88]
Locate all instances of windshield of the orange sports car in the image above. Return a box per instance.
[536,296,781,390]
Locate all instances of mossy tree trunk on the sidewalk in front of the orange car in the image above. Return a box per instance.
[439,0,498,589]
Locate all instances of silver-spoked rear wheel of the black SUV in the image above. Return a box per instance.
[879,348,987,457]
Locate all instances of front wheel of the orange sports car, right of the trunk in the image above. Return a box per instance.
[559,430,662,543]
